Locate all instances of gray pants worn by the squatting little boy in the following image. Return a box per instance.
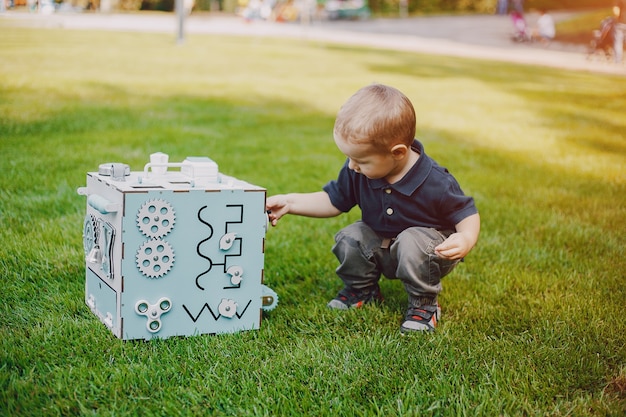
[333,221,459,306]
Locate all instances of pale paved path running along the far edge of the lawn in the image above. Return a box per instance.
[0,11,626,76]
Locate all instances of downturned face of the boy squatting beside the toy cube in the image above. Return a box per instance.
[335,138,398,179]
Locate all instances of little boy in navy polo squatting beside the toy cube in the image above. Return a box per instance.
[267,84,480,333]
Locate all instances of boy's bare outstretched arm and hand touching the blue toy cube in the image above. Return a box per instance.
[265,191,341,226]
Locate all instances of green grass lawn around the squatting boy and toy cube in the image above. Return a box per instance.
[0,20,626,416]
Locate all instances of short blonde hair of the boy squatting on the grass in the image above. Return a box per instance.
[333,84,415,152]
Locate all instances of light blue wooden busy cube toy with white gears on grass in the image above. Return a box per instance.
[78,153,277,339]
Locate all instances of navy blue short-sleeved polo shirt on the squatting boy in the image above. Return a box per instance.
[323,140,478,237]
